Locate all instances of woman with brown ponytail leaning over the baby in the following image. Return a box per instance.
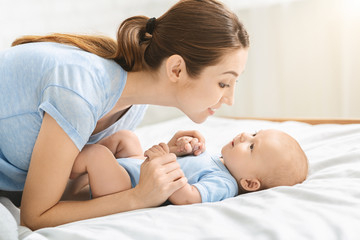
[0,0,249,230]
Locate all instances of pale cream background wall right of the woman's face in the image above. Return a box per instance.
[219,0,360,121]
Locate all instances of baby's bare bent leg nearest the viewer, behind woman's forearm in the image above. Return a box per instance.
[70,144,131,198]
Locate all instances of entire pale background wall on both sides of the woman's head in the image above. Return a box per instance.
[0,0,360,124]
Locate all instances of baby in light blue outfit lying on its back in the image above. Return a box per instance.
[70,129,308,205]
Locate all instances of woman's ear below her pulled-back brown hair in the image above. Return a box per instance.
[166,54,186,82]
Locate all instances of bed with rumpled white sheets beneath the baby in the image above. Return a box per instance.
[0,117,360,240]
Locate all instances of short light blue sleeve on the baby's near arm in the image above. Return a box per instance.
[194,171,238,202]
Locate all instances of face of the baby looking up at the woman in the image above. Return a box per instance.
[221,129,292,181]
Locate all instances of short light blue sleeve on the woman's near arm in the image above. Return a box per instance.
[38,66,104,150]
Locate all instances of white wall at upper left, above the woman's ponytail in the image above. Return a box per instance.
[0,0,176,46]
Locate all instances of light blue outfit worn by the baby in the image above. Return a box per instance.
[117,152,238,202]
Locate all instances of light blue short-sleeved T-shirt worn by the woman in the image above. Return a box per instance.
[0,43,147,191]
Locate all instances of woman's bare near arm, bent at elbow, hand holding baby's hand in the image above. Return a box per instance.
[20,114,186,230]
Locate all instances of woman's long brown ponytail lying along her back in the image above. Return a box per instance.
[12,16,152,71]
